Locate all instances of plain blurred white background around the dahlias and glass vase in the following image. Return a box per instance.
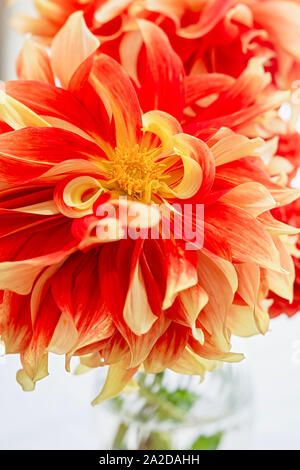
[0,0,300,449]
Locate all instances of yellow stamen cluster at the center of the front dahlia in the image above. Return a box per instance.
[108,145,163,202]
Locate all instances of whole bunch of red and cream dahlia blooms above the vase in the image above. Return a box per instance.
[0,0,300,430]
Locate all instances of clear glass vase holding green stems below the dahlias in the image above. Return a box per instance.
[98,364,253,450]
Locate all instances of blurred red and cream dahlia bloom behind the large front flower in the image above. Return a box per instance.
[17,0,300,178]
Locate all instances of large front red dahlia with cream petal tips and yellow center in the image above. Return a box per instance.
[0,14,299,403]
